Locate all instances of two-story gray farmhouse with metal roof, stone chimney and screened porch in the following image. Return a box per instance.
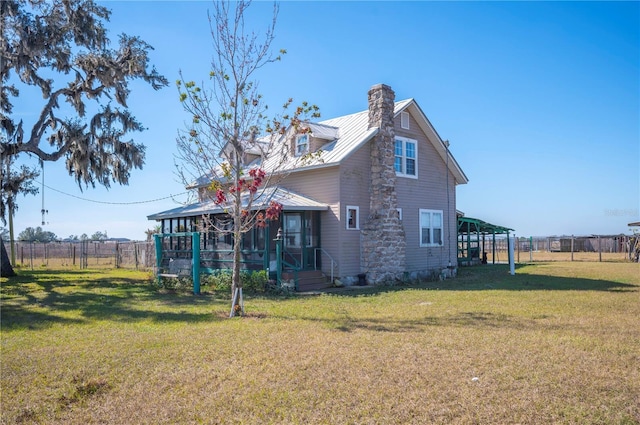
[148,84,468,288]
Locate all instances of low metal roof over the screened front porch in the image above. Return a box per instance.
[147,186,329,220]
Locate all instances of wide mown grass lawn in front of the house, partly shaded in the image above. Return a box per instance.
[0,262,640,424]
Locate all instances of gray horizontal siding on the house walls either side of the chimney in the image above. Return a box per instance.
[281,107,457,277]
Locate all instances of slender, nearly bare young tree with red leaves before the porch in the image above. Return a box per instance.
[176,0,319,315]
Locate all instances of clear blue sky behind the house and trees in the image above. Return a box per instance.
[7,1,640,239]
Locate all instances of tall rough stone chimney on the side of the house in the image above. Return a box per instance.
[360,84,406,284]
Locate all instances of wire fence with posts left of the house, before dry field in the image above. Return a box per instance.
[5,241,155,270]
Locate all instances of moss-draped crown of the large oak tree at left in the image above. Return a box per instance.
[0,0,168,220]
